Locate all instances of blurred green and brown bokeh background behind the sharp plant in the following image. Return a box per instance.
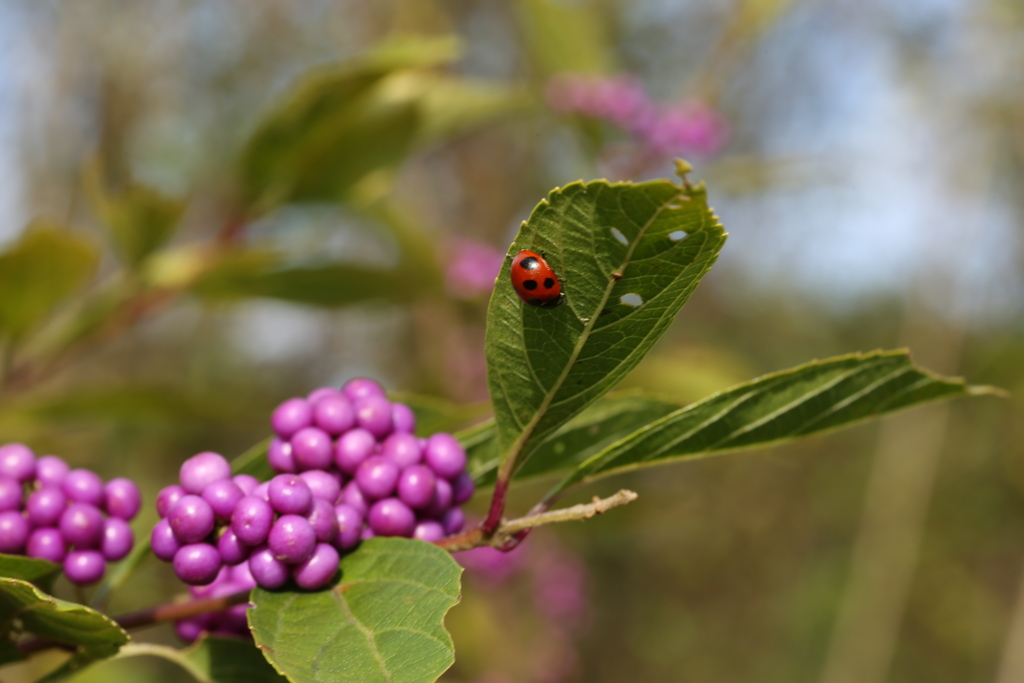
[0,0,1024,683]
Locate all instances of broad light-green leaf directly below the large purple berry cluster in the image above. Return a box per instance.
[249,538,462,683]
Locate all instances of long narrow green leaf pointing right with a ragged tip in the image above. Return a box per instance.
[559,350,997,489]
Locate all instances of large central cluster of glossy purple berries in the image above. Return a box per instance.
[152,379,473,590]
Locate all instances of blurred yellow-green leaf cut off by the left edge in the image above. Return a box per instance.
[0,222,98,339]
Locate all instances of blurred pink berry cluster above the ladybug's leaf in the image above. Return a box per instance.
[547,74,729,159]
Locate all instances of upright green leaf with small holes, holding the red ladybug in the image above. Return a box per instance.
[485,169,725,479]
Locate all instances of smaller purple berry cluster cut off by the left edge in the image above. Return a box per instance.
[0,443,141,586]
